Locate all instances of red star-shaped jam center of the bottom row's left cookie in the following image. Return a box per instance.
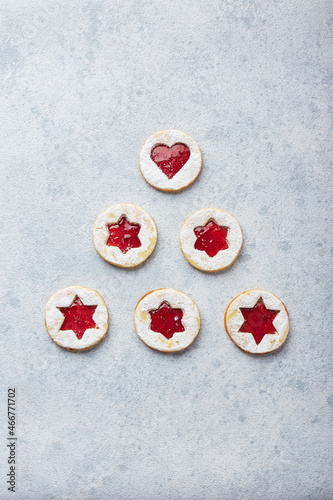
[58,295,98,340]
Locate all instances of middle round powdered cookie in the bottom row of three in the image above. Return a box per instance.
[134,288,200,352]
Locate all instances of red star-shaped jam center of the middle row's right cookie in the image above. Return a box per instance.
[194,219,229,257]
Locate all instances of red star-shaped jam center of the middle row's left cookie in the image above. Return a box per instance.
[106,215,141,253]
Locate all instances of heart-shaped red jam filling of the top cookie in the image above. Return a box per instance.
[150,143,191,179]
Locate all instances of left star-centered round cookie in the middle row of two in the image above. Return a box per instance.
[93,203,157,267]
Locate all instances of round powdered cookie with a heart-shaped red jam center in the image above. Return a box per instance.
[140,130,202,191]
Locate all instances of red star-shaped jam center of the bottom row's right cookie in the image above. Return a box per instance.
[239,297,280,345]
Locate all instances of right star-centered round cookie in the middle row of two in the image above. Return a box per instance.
[180,208,243,272]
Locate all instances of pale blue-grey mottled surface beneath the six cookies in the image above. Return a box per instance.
[0,0,333,500]
